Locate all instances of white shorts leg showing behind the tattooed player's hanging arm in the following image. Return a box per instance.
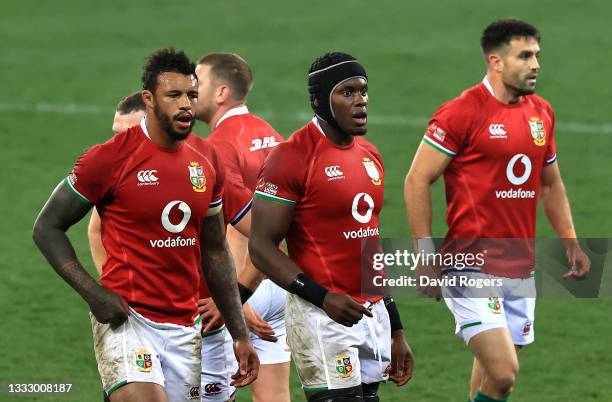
[200,327,238,402]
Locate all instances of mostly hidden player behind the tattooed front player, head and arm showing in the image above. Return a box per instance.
[87,91,146,275]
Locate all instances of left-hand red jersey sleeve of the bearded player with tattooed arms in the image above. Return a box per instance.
[64,145,114,205]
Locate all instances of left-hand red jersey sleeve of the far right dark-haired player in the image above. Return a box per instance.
[423,99,470,158]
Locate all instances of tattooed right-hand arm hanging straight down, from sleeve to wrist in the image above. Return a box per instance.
[200,212,248,340]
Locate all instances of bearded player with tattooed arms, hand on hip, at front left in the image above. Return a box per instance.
[33,49,259,402]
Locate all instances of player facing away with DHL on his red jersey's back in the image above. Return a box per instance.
[196,53,290,402]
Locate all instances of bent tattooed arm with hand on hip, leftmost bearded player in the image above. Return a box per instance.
[33,183,127,326]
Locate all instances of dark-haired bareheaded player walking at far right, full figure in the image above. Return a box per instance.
[404,20,590,402]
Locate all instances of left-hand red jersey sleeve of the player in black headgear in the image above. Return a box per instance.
[255,142,305,205]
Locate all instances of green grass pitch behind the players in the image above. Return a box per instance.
[0,0,612,402]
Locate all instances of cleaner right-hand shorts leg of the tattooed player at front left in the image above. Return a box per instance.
[162,325,202,402]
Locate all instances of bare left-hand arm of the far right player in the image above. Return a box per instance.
[404,141,452,298]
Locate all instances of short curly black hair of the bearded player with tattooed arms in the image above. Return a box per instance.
[142,47,195,92]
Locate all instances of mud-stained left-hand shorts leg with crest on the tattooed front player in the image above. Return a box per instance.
[90,313,165,395]
